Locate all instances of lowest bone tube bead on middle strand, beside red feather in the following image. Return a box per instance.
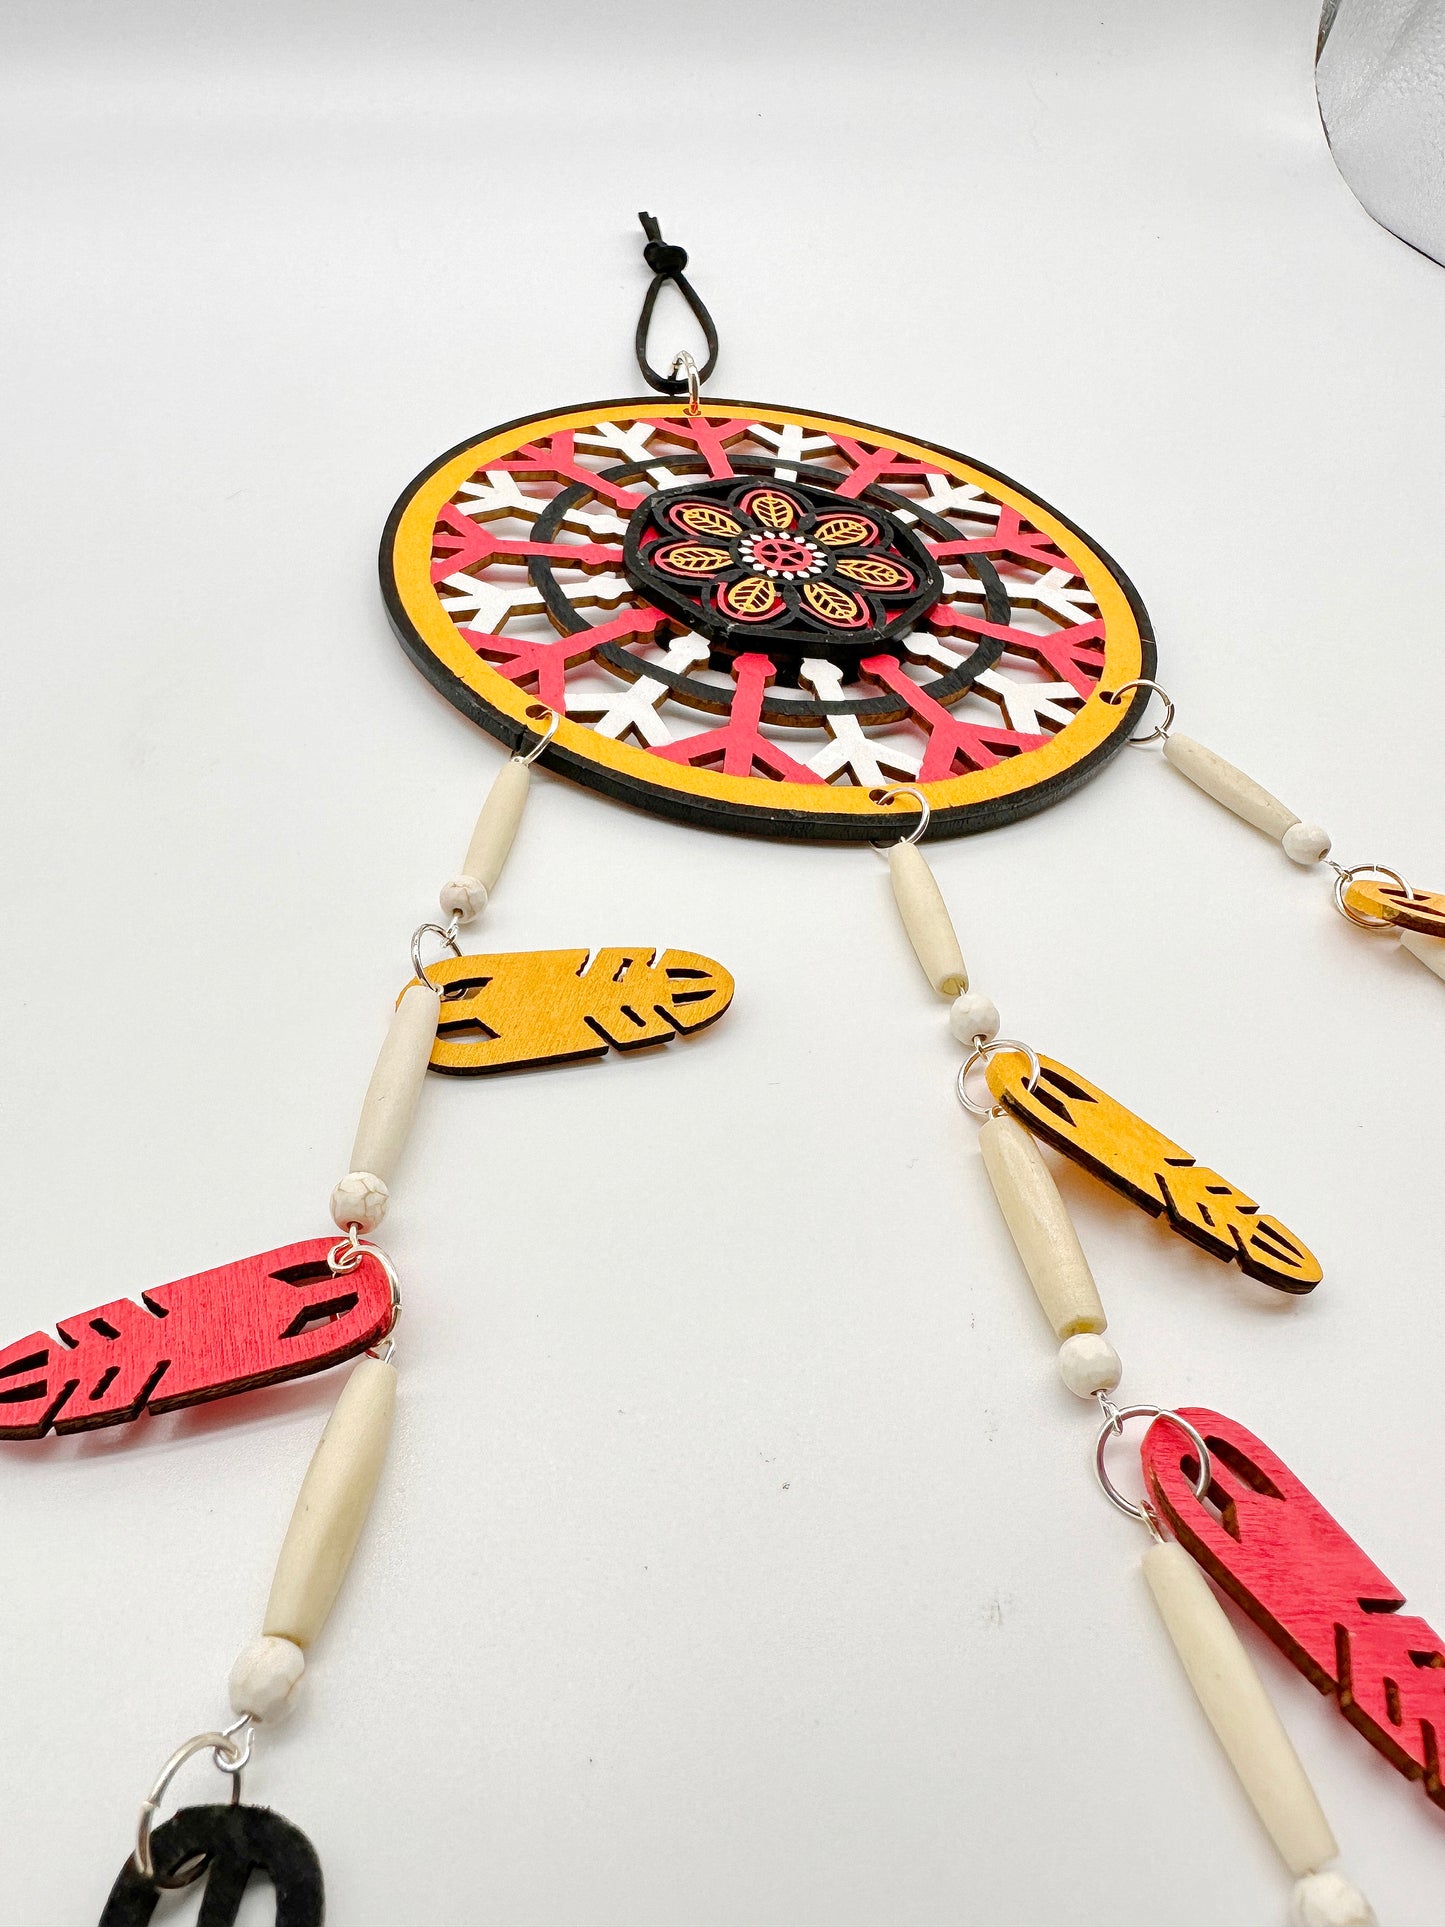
[1143,1544,1339,1875]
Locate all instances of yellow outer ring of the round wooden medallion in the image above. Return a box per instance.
[383,397,1154,834]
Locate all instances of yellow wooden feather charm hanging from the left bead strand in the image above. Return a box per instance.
[408,944,732,1077]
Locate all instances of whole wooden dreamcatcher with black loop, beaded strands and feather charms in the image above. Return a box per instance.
[22,216,1445,1927]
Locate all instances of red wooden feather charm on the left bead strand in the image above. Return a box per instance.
[0,1235,395,1439]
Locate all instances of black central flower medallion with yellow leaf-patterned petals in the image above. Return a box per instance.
[626,476,942,669]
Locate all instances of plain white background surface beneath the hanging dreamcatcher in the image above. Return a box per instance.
[0,0,1445,1927]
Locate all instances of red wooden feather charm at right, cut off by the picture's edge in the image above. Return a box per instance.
[1143,1407,1445,1806]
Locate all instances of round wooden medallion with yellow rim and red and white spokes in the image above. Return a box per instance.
[381,397,1154,842]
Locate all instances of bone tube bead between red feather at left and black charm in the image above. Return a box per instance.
[262,1359,397,1651]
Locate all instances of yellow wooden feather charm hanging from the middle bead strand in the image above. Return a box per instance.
[986,1050,1324,1291]
